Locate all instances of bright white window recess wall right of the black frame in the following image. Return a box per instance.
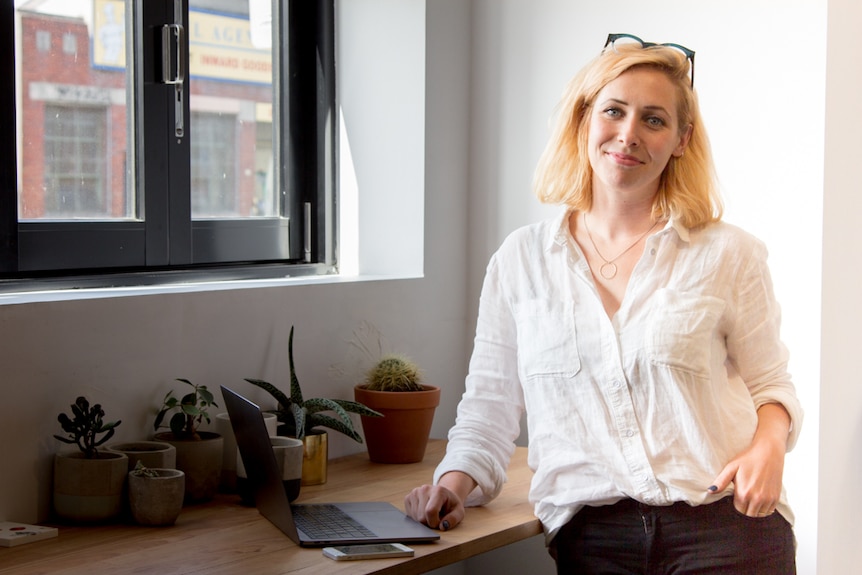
[336,0,428,277]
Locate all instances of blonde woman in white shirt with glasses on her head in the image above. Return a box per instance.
[405,34,802,575]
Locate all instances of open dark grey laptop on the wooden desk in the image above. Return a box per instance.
[221,386,440,547]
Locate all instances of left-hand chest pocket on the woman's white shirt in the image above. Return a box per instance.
[514,300,581,380]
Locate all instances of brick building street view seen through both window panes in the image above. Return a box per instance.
[15,0,279,222]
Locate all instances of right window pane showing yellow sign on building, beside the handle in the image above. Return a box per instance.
[188,0,280,219]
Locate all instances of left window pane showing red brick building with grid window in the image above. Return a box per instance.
[16,0,137,221]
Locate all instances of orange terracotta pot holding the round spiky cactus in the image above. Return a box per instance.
[353,385,440,463]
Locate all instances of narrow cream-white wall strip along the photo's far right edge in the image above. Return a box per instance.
[816,0,862,575]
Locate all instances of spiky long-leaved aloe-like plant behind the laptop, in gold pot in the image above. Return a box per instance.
[246,326,383,443]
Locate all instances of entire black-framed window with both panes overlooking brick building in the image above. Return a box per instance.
[0,0,337,290]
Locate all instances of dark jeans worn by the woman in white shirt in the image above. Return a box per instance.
[549,497,796,575]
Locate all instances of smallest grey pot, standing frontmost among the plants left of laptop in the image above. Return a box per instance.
[129,469,186,526]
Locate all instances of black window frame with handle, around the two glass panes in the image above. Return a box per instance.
[0,0,338,292]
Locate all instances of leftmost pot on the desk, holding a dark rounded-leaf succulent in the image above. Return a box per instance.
[54,450,129,523]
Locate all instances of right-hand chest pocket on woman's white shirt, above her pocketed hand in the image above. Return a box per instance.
[646,289,725,377]
